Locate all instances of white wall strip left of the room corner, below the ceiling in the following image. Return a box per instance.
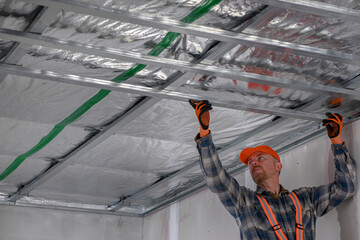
[0,206,143,240]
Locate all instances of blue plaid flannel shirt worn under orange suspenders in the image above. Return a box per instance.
[195,133,356,240]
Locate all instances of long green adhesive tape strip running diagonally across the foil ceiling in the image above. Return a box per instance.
[0,0,222,181]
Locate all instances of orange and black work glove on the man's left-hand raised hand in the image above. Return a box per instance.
[189,100,212,137]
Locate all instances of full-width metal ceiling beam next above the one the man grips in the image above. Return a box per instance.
[0,29,360,100]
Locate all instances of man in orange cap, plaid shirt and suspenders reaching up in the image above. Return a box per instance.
[190,100,356,240]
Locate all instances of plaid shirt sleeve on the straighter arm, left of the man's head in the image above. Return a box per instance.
[195,133,241,218]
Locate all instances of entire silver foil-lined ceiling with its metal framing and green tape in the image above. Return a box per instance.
[0,0,360,217]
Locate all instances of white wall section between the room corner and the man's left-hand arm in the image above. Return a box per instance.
[143,190,239,240]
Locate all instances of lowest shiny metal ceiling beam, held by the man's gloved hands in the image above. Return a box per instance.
[0,64,325,121]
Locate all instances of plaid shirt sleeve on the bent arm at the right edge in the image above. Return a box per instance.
[309,143,356,217]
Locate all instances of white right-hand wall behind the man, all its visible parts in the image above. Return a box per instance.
[143,121,360,240]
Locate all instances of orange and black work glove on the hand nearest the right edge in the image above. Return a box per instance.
[323,112,344,144]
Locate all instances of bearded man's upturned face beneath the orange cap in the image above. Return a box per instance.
[248,152,282,184]
